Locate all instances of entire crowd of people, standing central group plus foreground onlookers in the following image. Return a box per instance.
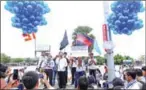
[0,52,146,90]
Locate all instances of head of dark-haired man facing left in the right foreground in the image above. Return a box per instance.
[125,69,136,82]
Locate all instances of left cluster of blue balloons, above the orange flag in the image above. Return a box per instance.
[5,0,50,34]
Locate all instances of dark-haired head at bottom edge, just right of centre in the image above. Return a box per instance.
[79,76,88,90]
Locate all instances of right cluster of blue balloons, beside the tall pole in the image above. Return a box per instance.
[107,0,145,35]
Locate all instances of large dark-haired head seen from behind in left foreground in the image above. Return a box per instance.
[22,71,39,89]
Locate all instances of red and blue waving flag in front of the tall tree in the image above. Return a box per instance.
[76,34,93,46]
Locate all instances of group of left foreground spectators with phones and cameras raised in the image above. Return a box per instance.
[0,64,54,90]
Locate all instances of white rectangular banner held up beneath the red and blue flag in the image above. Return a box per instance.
[71,46,88,57]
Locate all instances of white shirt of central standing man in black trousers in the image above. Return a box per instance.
[56,58,67,71]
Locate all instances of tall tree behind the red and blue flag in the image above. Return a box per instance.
[72,26,95,52]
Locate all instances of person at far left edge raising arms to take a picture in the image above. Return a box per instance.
[0,64,19,89]
